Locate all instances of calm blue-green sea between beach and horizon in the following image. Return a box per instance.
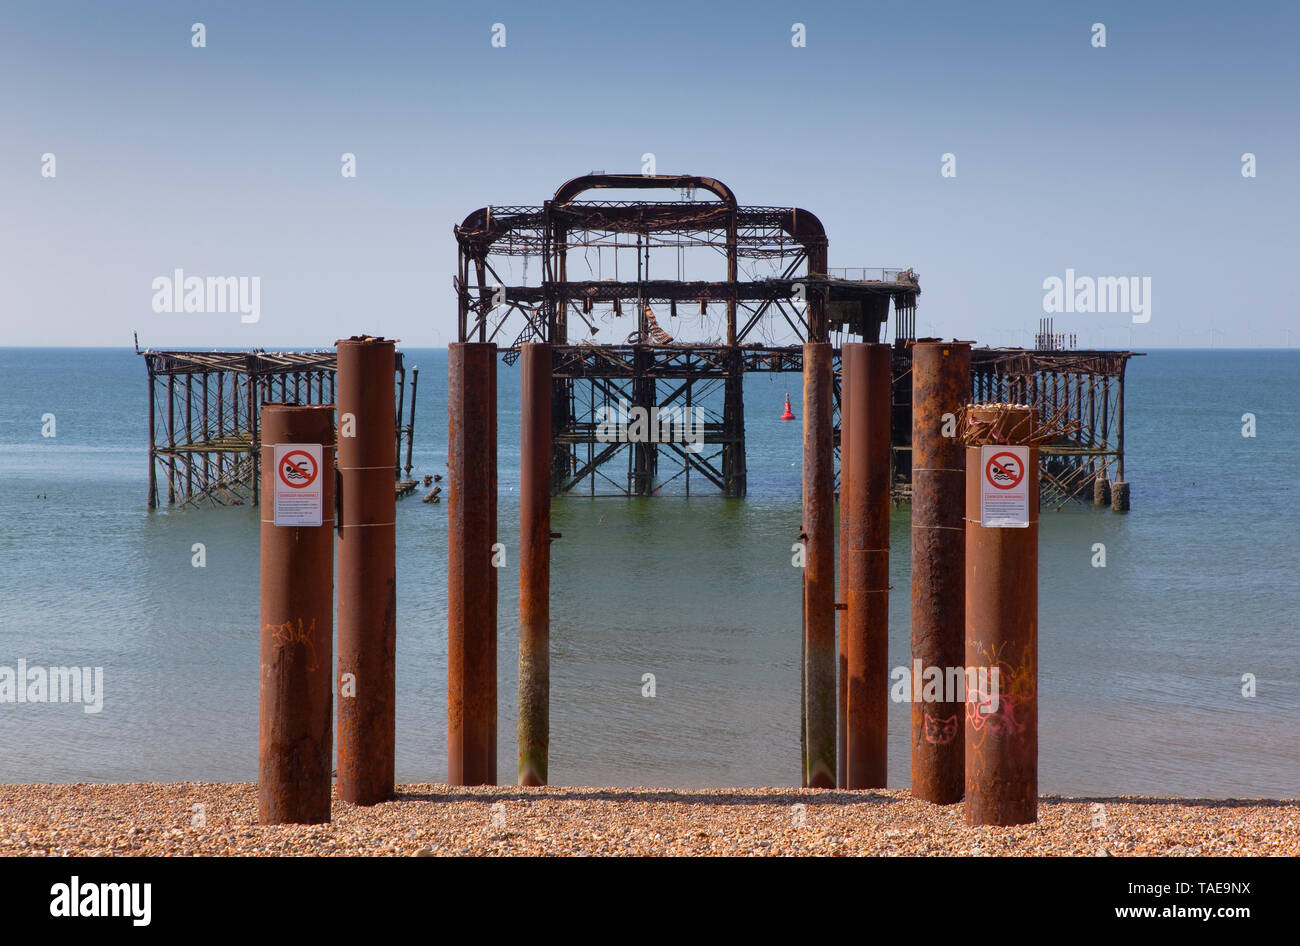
[0,348,1300,798]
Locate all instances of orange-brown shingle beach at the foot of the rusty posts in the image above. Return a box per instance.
[0,782,1300,856]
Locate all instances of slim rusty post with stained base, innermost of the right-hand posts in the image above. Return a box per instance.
[801,342,836,789]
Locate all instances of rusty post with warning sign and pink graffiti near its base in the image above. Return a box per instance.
[965,405,1039,825]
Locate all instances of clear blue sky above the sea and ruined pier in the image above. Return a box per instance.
[0,0,1300,350]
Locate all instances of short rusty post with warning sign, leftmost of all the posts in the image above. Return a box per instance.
[257,404,334,824]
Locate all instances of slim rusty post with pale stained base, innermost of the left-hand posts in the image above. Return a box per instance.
[517,343,551,785]
